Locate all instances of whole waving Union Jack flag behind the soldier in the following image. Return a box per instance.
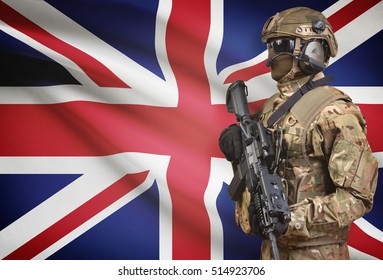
[0,0,383,259]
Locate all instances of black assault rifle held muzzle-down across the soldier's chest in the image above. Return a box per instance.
[226,81,291,260]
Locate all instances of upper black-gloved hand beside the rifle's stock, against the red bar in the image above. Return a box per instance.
[219,124,242,161]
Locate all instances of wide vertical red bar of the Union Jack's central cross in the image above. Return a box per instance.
[166,0,213,259]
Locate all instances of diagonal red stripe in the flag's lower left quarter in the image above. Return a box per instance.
[4,171,148,260]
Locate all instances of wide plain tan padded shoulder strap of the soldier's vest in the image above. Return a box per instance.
[290,88,351,128]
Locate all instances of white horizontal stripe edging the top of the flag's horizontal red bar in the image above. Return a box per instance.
[0,84,383,107]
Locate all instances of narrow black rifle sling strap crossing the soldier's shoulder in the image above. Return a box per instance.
[267,76,332,127]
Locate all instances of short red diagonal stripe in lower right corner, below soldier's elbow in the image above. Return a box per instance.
[348,223,383,259]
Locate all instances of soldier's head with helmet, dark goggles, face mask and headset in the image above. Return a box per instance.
[262,7,338,82]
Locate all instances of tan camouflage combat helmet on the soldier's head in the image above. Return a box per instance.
[262,7,338,57]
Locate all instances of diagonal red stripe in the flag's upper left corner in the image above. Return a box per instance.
[0,1,129,88]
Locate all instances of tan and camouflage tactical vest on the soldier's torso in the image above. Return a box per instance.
[263,86,351,205]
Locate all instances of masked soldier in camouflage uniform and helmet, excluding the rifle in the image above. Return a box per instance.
[219,7,378,259]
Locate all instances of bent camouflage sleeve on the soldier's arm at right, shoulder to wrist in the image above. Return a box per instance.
[285,101,378,238]
